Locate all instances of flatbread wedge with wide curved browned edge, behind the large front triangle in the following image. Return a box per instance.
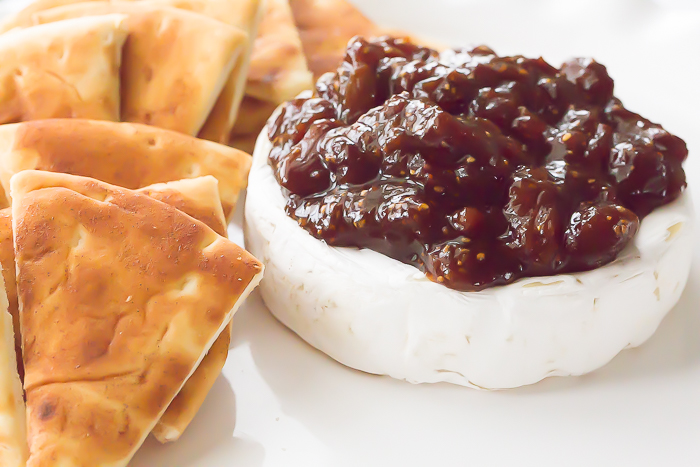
[0,119,251,219]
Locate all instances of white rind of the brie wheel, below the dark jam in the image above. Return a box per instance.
[245,132,693,389]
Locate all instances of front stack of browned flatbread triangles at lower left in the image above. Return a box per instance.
[0,125,263,466]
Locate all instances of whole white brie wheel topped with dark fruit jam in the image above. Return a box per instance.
[245,38,692,389]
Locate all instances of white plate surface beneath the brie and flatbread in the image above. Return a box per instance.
[0,0,700,467]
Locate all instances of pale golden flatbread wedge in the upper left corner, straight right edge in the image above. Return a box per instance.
[0,15,126,123]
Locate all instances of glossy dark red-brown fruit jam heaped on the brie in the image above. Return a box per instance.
[269,38,688,290]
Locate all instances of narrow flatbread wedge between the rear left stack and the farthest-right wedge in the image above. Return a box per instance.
[246,0,313,104]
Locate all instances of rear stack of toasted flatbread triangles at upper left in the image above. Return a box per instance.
[0,0,262,142]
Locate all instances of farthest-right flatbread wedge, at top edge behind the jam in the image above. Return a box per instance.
[289,0,381,78]
